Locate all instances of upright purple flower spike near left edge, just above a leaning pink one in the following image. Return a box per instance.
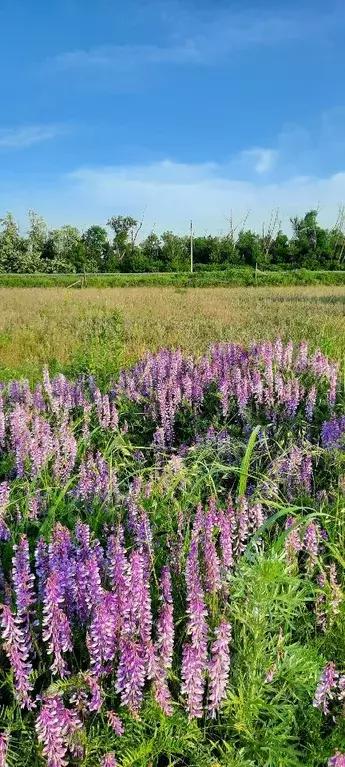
[12,535,35,650]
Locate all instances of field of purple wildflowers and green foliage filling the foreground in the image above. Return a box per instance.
[0,338,345,767]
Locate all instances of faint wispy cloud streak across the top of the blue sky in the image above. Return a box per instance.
[55,5,334,71]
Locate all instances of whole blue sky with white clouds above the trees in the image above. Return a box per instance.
[0,0,345,232]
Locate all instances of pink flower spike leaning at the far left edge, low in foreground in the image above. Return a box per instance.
[0,605,34,709]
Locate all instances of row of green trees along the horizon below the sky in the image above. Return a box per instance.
[0,210,345,273]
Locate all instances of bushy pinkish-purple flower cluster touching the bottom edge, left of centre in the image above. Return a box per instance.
[36,694,82,767]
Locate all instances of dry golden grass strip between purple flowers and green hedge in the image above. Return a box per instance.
[0,286,345,377]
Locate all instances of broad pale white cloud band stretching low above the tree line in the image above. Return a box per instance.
[0,161,345,233]
